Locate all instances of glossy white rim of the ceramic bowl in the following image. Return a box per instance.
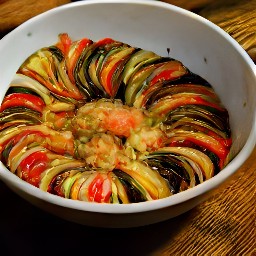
[0,0,256,214]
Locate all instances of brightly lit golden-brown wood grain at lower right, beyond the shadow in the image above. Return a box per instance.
[159,148,256,256]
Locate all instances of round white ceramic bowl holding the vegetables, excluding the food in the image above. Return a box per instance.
[0,0,256,227]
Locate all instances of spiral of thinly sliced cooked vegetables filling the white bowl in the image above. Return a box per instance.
[0,33,232,204]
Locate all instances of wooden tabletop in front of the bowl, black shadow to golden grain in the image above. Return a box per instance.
[0,0,256,256]
